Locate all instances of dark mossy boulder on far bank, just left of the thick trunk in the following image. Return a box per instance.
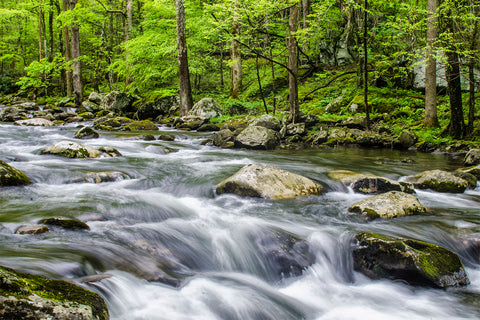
[136,94,180,120]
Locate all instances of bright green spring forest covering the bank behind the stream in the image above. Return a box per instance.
[0,0,480,148]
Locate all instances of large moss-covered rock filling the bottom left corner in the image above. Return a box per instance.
[0,267,109,320]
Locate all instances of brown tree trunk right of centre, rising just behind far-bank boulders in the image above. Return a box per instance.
[288,4,300,123]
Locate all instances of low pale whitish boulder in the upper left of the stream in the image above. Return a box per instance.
[41,140,120,158]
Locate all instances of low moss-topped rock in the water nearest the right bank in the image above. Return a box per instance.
[406,170,468,193]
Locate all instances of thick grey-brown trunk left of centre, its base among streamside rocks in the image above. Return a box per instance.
[176,0,193,116]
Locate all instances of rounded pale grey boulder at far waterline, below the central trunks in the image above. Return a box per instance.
[235,126,280,150]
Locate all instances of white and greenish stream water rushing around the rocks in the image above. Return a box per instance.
[0,124,480,320]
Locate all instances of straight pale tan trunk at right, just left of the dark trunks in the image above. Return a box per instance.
[424,0,438,127]
